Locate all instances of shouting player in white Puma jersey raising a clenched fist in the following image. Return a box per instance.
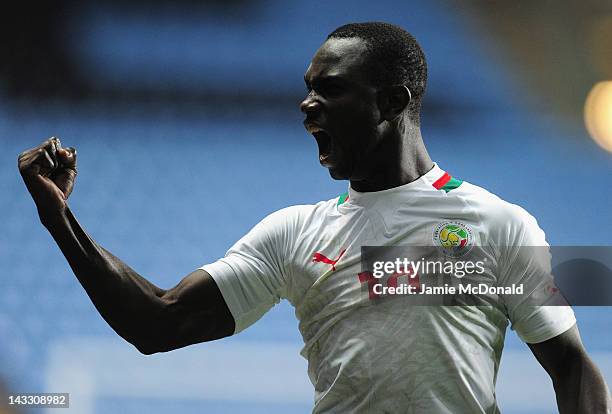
[19,23,609,413]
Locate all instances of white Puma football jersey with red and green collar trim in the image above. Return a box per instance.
[202,165,575,413]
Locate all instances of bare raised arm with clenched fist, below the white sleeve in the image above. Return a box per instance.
[18,138,234,354]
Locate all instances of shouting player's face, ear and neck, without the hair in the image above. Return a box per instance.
[300,39,433,192]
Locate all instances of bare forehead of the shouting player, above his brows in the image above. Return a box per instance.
[304,37,367,81]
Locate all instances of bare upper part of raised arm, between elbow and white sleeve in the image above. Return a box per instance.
[162,269,235,351]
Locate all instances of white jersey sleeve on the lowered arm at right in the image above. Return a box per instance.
[498,205,576,343]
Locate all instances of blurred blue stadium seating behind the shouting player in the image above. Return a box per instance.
[0,1,612,414]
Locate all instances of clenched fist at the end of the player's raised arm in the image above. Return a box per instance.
[18,137,77,223]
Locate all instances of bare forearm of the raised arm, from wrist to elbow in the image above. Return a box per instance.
[41,207,164,352]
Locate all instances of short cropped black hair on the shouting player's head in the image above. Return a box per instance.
[327,22,427,125]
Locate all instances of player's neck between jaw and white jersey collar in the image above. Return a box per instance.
[350,116,433,192]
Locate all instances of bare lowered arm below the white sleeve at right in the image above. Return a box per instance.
[528,325,612,414]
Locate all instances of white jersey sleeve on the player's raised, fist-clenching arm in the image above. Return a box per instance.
[201,207,297,334]
